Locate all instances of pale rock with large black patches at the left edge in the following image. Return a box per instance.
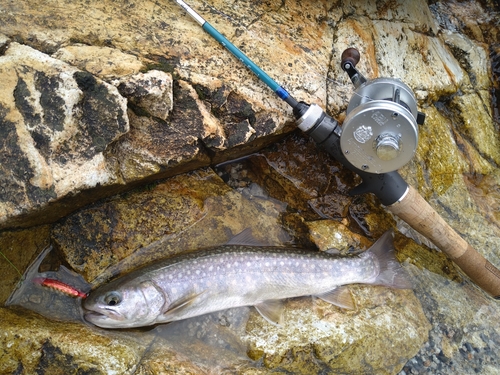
[0,43,129,227]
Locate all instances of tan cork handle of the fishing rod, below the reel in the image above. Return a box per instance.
[388,186,500,299]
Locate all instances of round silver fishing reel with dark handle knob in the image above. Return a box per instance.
[340,48,425,173]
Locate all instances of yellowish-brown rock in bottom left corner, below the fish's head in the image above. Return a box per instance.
[0,307,147,374]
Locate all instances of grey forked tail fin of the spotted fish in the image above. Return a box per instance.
[368,230,413,289]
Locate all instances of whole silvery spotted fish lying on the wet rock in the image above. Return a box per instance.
[83,231,411,328]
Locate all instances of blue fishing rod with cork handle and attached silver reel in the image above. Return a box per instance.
[175,0,500,299]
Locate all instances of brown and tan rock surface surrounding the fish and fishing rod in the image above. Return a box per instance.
[0,0,500,375]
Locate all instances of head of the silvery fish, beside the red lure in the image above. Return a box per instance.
[83,281,167,328]
